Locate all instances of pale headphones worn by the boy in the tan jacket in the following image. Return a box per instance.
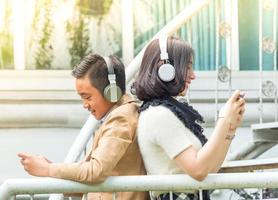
[103,57,122,103]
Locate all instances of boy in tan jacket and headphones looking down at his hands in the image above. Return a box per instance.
[18,54,148,200]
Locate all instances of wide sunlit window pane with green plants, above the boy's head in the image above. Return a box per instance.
[25,0,121,69]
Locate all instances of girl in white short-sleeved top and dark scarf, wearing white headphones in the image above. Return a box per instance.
[133,37,245,200]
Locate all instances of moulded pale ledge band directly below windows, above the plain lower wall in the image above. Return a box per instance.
[0,70,278,128]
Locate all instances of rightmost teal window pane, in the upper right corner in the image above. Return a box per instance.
[238,0,278,70]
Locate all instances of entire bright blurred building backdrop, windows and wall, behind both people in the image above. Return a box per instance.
[0,0,278,199]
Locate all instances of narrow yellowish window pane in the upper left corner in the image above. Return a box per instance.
[0,0,14,69]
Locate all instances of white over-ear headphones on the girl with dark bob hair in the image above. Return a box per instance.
[158,35,176,82]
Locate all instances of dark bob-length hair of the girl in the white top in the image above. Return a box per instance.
[132,37,194,101]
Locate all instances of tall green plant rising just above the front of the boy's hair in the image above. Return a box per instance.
[66,11,90,68]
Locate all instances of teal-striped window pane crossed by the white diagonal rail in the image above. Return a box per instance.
[134,0,226,70]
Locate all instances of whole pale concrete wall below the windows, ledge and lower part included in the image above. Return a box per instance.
[0,71,278,199]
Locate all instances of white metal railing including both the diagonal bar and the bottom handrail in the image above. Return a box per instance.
[0,0,278,200]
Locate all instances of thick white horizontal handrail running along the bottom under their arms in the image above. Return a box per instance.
[0,172,278,200]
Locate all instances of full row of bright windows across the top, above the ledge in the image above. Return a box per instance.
[0,0,277,71]
